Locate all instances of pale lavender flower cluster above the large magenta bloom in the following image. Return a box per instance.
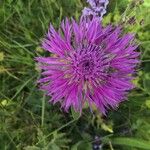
[82,0,109,21]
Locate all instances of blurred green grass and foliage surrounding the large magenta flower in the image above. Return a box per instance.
[0,0,150,150]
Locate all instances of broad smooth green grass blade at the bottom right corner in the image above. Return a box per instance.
[112,137,150,150]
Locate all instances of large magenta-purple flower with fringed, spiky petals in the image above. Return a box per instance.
[37,19,139,114]
